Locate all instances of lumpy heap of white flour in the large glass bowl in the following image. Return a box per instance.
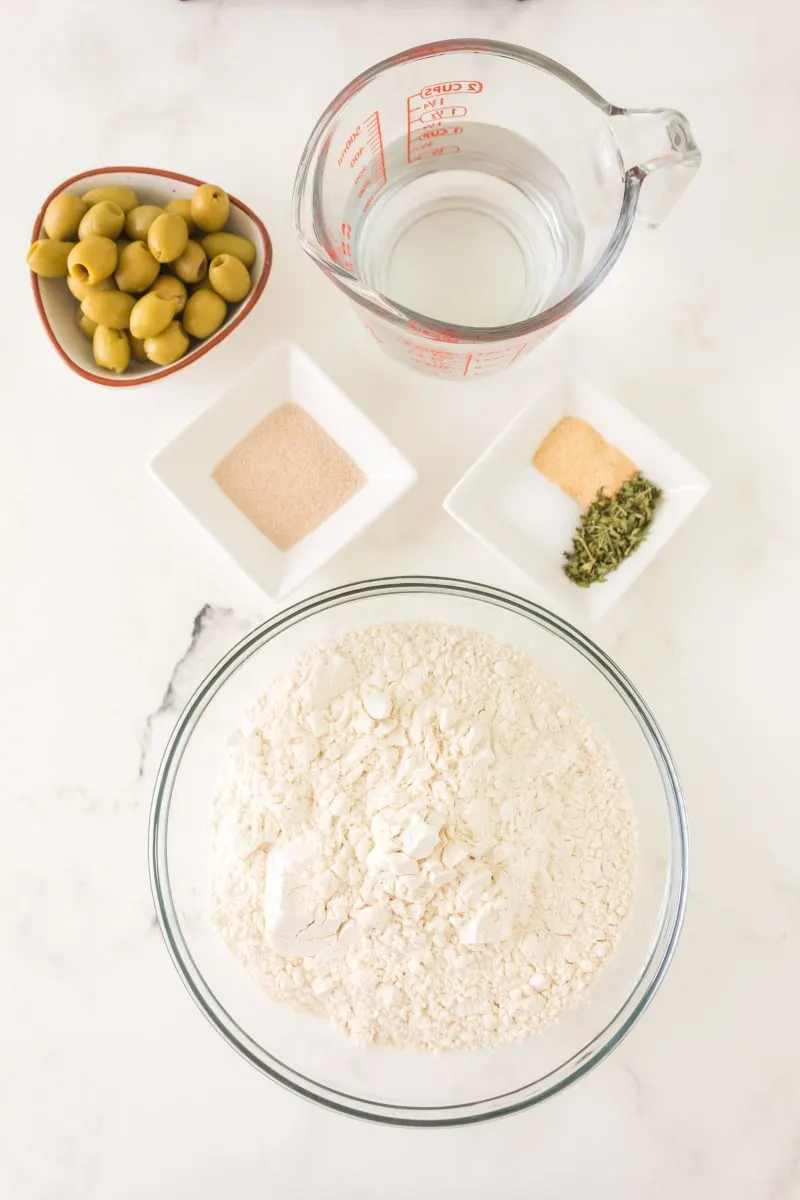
[211,624,636,1050]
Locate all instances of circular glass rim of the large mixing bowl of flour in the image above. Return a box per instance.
[148,575,688,1128]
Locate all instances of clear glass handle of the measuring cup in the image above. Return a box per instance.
[609,108,702,227]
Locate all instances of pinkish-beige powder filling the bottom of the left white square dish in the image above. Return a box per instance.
[211,402,367,551]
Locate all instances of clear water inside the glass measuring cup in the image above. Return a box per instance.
[345,122,584,328]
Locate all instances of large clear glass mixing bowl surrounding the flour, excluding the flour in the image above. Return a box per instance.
[150,577,687,1126]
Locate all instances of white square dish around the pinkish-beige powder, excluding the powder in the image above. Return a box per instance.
[149,342,416,599]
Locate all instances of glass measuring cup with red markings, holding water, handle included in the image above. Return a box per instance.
[294,38,700,378]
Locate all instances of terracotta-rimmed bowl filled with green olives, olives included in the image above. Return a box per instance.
[28,167,272,388]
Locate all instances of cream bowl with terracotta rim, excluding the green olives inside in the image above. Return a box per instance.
[31,167,272,388]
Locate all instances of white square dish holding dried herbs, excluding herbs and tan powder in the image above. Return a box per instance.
[444,376,710,622]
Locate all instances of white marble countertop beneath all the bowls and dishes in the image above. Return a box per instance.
[0,0,800,1200]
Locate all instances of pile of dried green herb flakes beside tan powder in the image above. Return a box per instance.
[564,472,661,588]
